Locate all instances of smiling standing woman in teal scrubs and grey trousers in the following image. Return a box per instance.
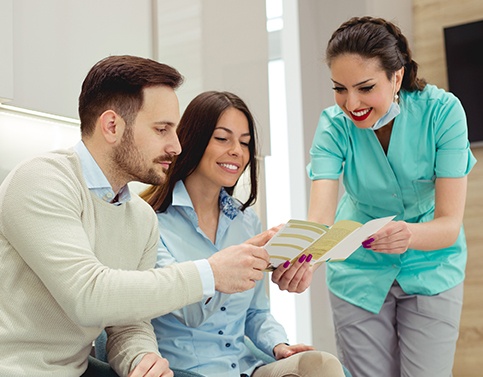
[307,17,476,377]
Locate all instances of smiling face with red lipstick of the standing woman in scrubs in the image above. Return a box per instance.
[330,54,404,128]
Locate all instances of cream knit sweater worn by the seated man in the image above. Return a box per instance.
[0,150,202,377]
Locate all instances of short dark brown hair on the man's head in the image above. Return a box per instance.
[79,55,183,137]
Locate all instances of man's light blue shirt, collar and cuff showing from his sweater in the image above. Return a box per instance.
[74,141,215,300]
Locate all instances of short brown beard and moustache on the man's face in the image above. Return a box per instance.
[113,127,173,185]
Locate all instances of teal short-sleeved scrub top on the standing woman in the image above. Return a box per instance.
[307,85,476,313]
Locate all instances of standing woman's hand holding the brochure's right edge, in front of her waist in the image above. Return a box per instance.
[362,221,412,254]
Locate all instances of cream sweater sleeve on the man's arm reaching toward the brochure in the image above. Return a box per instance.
[0,158,202,327]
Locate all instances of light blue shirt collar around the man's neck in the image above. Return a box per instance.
[74,141,131,205]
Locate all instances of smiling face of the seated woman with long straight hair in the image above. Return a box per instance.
[193,107,251,188]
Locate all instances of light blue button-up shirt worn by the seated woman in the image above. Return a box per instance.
[152,181,287,377]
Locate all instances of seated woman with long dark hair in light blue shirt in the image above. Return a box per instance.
[144,92,344,377]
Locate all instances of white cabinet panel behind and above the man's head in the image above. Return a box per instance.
[8,0,153,118]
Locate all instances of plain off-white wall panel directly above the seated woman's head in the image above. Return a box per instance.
[202,0,270,156]
